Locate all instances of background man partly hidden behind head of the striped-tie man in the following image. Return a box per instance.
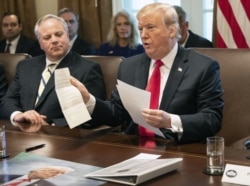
[58,8,96,55]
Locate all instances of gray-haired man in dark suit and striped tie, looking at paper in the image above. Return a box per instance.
[0,14,105,126]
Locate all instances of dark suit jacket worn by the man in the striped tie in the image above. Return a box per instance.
[1,52,106,125]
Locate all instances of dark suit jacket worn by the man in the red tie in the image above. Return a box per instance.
[92,47,224,143]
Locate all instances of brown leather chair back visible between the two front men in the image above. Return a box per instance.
[82,55,123,99]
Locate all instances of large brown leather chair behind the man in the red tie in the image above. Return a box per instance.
[192,48,250,146]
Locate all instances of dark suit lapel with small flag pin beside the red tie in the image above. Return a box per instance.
[160,47,188,110]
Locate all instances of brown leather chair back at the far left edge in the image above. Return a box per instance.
[0,53,31,84]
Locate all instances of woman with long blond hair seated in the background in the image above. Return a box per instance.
[98,10,144,58]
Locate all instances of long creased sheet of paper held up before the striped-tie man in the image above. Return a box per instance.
[55,68,91,128]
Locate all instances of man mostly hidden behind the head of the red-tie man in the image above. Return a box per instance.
[173,6,213,48]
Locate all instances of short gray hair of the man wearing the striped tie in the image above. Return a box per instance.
[34,14,68,39]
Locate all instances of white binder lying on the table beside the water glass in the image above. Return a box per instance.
[84,158,182,185]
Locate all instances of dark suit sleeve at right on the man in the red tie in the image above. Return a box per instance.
[166,62,224,143]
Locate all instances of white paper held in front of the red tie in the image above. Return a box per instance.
[116,80,165,138]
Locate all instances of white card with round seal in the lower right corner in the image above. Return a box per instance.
[222,164,250,185]
